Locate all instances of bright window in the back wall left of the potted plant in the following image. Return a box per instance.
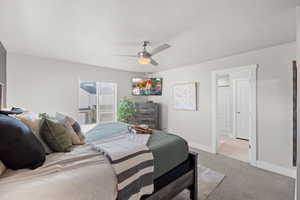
[79,81,117,124]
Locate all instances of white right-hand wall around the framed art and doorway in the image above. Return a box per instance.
[150,42,296,167]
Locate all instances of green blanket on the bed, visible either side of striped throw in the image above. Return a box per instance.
[86,122,189,179]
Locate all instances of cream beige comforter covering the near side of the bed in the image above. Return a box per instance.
[0,145,117,200]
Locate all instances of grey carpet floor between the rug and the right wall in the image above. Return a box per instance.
[192,149,295,200]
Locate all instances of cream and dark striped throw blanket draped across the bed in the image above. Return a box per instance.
[92,134,154,200]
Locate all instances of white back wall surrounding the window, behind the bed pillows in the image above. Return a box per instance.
[7,53,145,118]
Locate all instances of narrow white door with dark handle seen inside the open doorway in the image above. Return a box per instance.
[235,80,250,140]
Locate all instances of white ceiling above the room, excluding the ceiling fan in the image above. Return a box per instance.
[0,0,298,72]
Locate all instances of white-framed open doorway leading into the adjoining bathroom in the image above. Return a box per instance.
[212,65,257,166]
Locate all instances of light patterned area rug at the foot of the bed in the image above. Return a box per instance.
[173,165,225,200]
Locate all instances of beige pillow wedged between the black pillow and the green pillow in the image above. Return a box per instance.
[15,111,52,154]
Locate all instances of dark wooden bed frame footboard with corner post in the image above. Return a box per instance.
[146,152,198,200]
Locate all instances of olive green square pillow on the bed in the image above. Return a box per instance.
[40,117,72,152]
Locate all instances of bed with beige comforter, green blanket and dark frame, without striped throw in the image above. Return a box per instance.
[0,123,197,200]
